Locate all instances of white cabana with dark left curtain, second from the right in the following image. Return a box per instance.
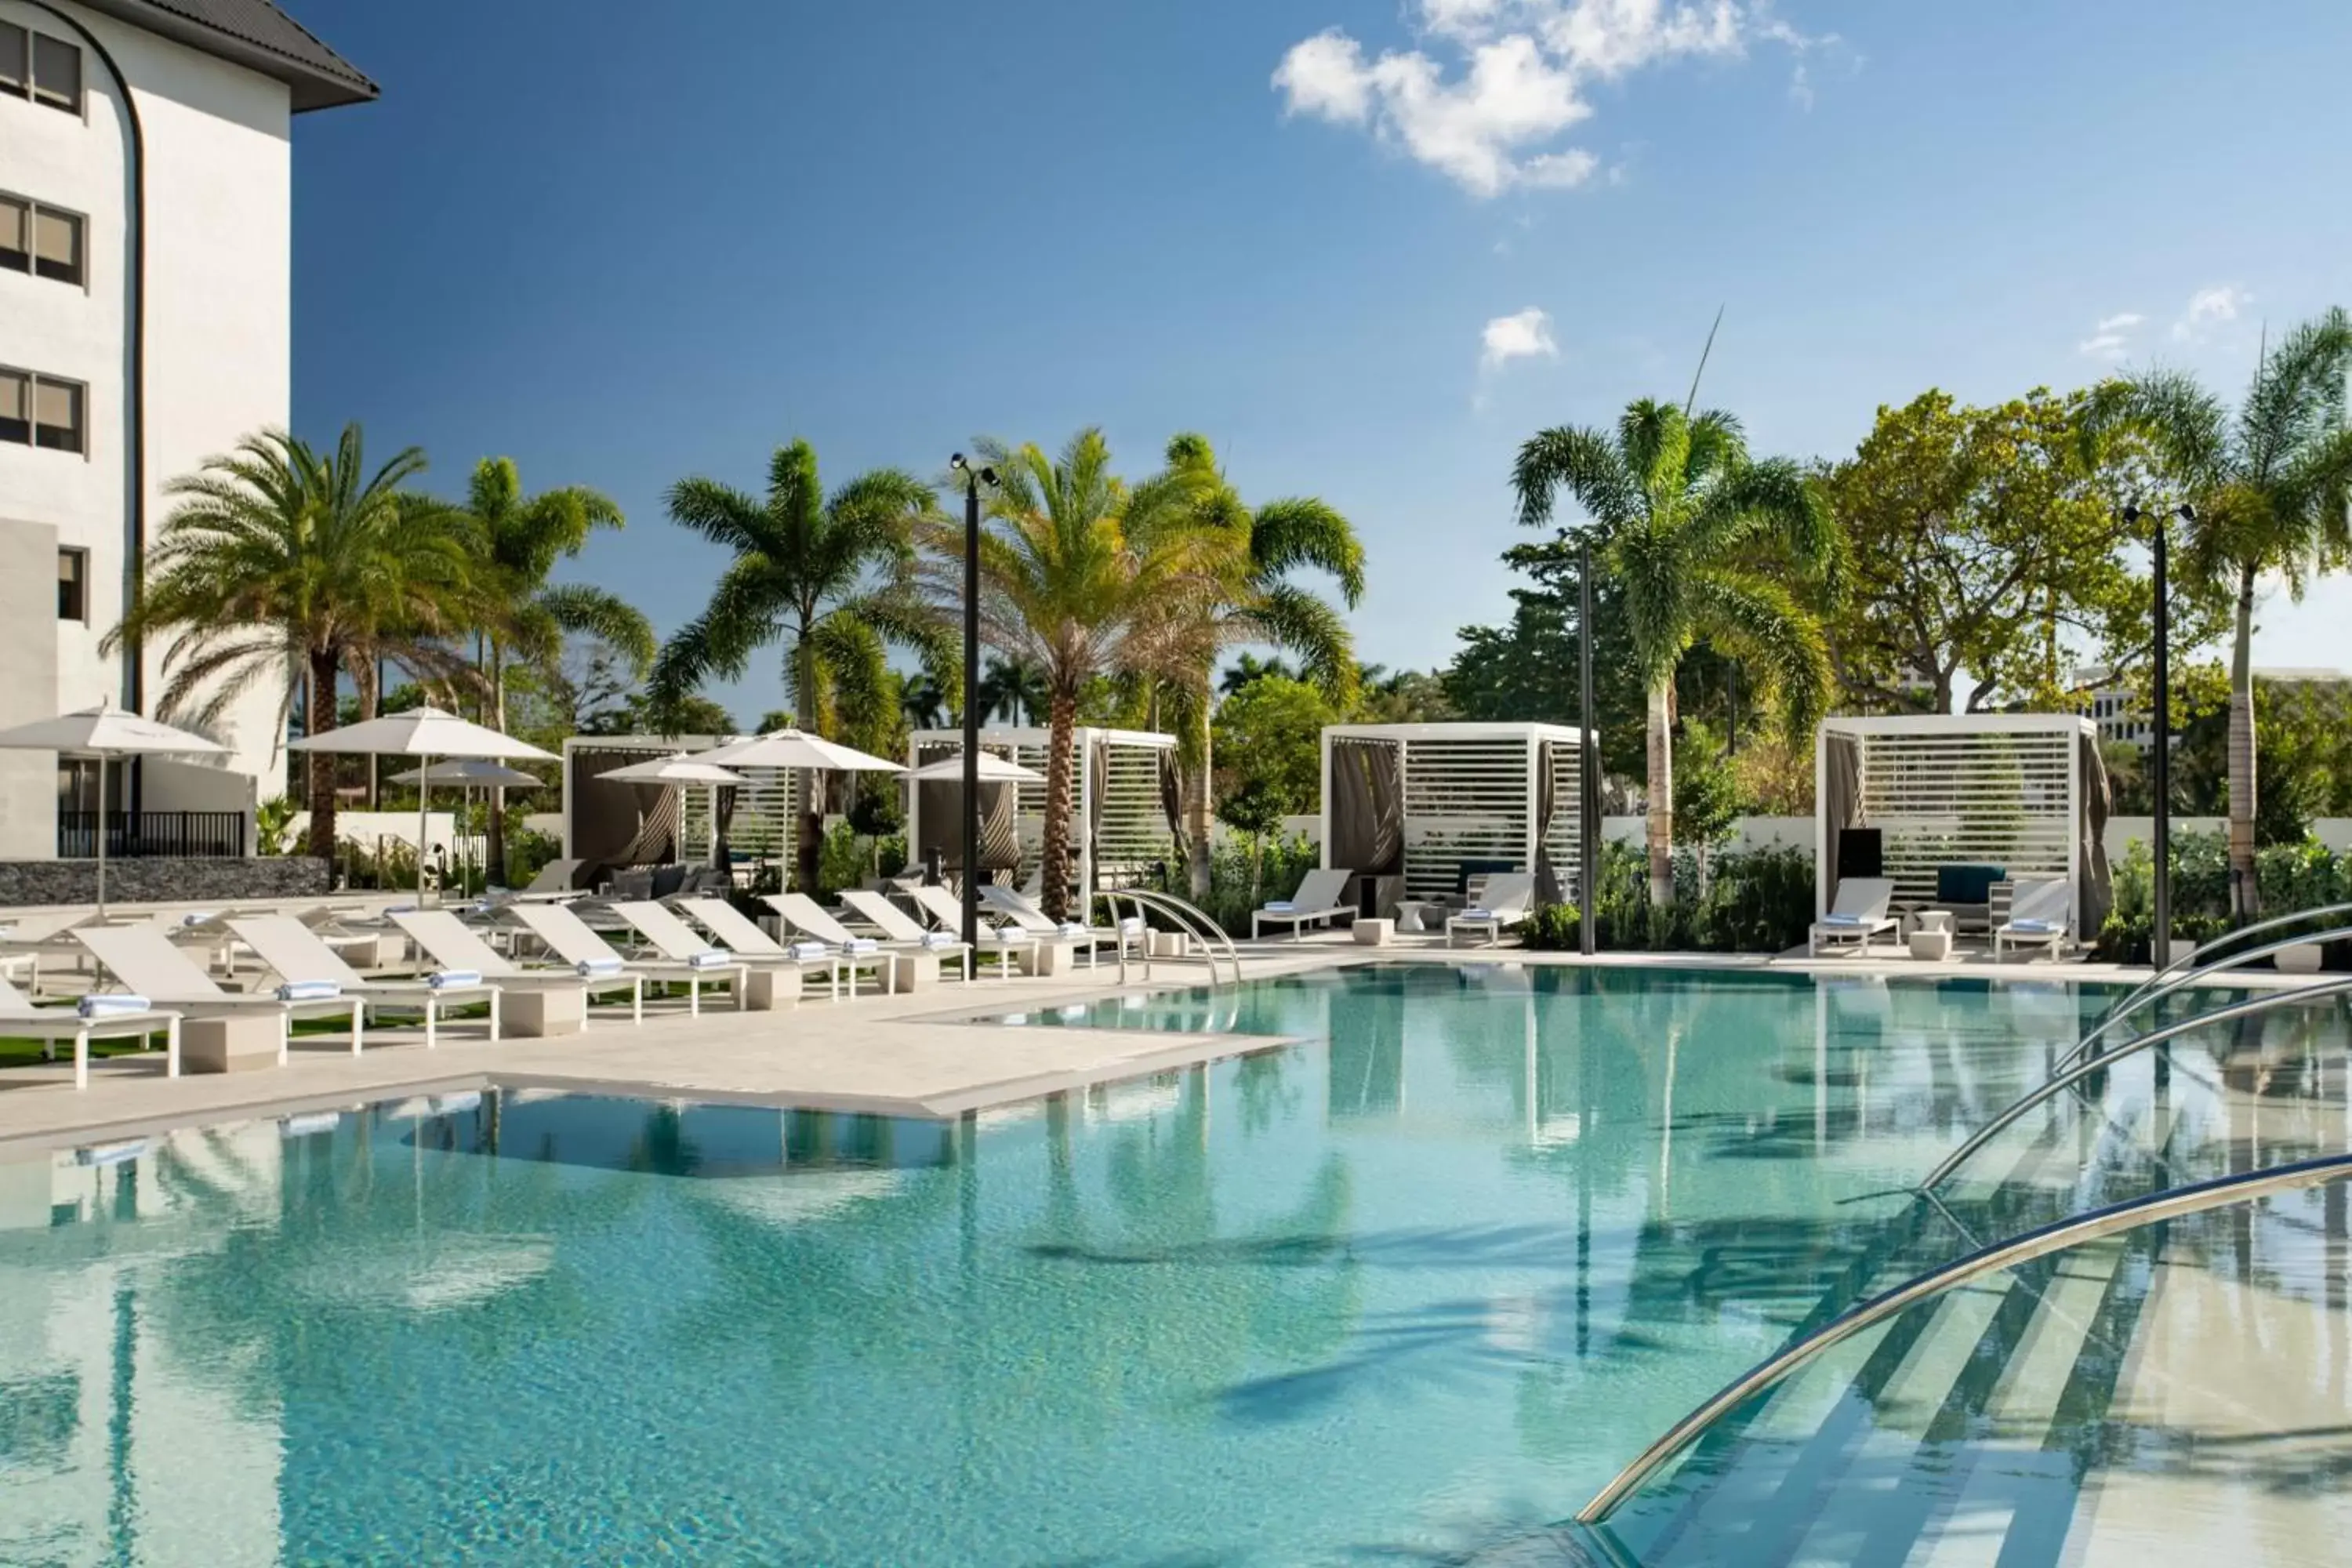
[1322,724,1585,912]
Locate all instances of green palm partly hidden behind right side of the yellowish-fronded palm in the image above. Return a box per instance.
[1164,435,1364,898]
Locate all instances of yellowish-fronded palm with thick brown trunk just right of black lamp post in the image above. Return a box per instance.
[924,430,1244,916]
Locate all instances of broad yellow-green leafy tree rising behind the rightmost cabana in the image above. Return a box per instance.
[1825,388,2201,713]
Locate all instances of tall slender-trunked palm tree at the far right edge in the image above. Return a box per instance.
[2091,310,2352,921]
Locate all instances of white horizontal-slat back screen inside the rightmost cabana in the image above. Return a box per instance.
[1858,731,2077,900]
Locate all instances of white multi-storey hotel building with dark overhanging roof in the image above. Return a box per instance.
[0,0,376,860]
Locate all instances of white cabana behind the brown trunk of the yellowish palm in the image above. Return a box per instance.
[906,727,1176,909]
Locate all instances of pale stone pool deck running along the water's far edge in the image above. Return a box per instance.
[0,935,2296,1152]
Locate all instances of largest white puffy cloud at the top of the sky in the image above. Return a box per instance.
[1272,0,1830,198]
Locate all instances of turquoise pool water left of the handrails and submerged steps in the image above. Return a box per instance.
[0,966,2105,1568]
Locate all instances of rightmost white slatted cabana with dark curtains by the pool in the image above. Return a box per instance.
[1813,713,2112,940]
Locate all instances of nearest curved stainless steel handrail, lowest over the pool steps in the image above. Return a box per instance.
[1576,1154,2352,1526]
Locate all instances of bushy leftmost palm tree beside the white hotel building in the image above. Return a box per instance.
[103,423,473,858]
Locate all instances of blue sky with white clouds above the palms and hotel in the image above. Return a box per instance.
[289,0,2352,722]
